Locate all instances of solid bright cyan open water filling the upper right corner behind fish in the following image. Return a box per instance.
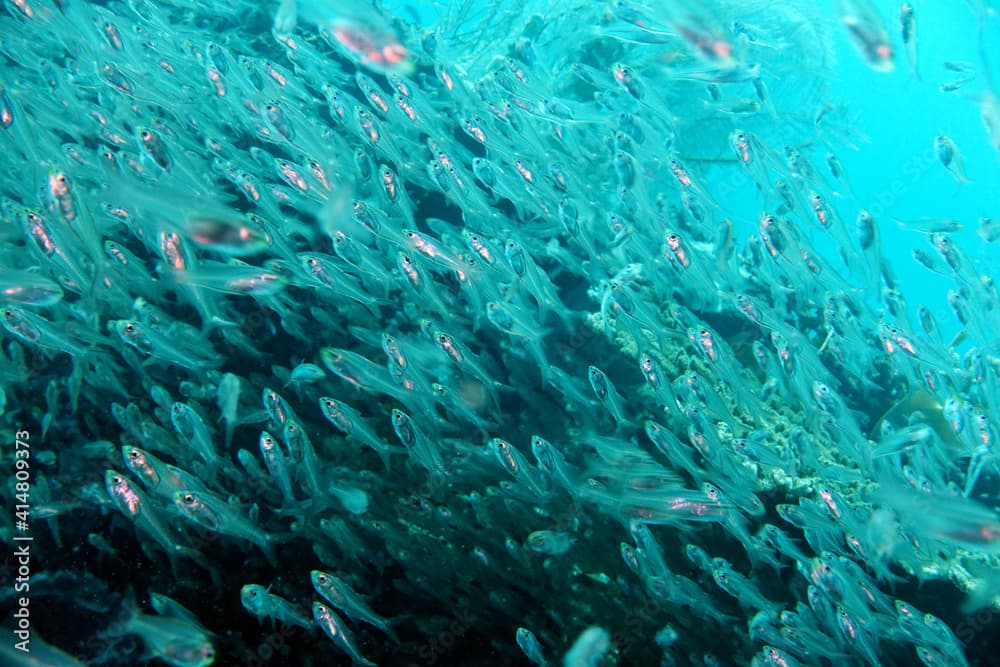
[824,1,1000,338]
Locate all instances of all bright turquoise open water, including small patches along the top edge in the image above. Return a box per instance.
[398,0,1000,340]
